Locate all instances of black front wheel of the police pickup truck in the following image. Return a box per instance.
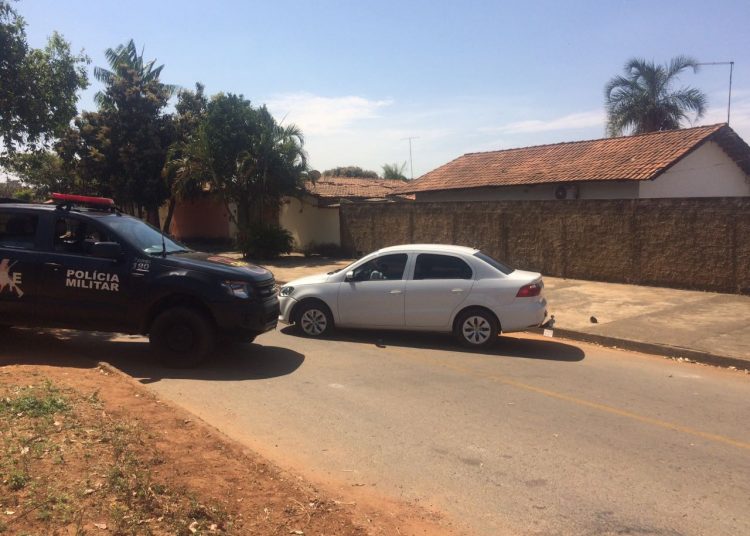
[149,307,216,368]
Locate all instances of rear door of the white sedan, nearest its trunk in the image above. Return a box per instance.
[404,253,474,330]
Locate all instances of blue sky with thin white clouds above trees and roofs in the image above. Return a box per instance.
[15,0,750,177]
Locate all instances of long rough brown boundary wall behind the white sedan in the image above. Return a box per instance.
[341,197,750,294]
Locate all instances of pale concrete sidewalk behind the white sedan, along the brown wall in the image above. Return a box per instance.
[265,256,750,369]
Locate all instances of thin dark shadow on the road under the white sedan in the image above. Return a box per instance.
[281,326,586,362]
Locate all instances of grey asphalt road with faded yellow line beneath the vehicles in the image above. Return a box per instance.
[7,326,750,536]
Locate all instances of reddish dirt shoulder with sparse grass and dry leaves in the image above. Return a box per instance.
[0,332,462,535]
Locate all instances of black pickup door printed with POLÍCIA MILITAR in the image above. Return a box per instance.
[36,213,132,330]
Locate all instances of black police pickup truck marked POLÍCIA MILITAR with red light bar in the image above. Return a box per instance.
[0,194,279,367]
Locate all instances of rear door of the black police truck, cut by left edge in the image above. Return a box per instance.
[0,208,41,325]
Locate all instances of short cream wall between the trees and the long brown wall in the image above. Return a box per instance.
[279,198,341,250]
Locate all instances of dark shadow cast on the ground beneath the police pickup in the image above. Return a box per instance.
[0,329,305,383]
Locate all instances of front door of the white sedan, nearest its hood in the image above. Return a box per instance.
[338,253,409,328]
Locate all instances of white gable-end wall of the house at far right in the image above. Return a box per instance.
[639,141,750,198]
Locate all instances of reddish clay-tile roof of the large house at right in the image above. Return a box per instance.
[397,123,750,194]
